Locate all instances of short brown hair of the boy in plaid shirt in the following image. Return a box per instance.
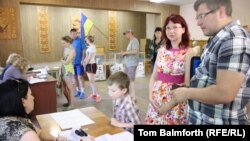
[107,71,130,93]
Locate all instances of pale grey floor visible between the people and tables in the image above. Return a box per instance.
[57,75,150,122]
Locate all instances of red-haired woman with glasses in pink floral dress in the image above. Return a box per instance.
[145,15,194,125]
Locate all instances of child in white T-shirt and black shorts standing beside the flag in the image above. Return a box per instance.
[84,35,101,102]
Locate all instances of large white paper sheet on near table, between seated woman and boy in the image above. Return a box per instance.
[50,109,95,130]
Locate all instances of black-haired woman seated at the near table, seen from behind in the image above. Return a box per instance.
[0,79,67,141]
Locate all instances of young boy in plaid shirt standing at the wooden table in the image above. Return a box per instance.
[107,72,141,133]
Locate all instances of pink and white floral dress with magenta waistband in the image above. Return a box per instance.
[145,47,187,125]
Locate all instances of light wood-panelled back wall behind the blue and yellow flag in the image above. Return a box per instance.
[20,5,146,62]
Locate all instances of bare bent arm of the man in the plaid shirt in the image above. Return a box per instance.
[171,69,244,104]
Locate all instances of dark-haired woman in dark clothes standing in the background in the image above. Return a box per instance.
[148,27,163,72]
